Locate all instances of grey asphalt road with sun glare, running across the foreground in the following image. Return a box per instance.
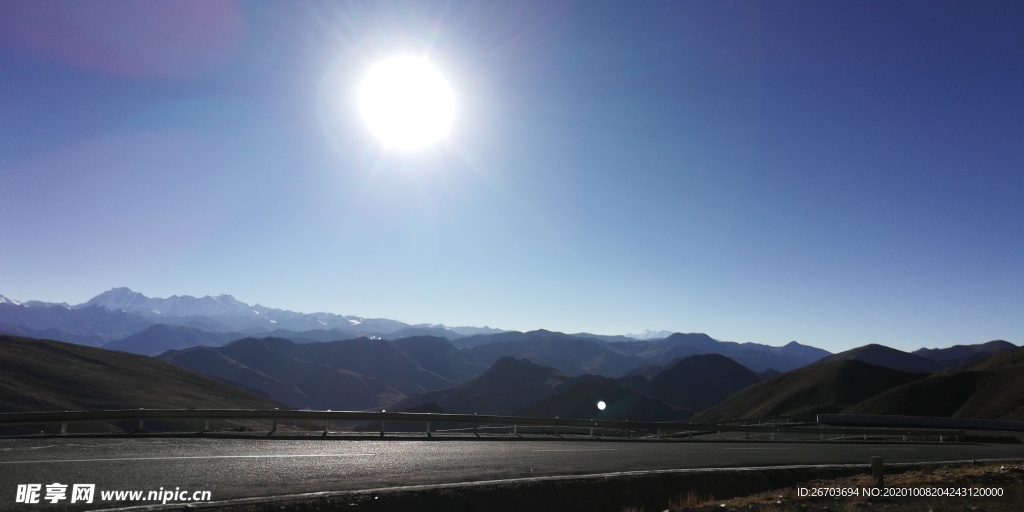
[0,438,1024,510]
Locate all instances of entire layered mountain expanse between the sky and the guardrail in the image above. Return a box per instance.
[0,289,1024,428]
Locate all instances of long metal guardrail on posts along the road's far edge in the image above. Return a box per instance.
[0,409,964,441]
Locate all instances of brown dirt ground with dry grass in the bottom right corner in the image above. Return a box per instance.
[663,463,1024,512]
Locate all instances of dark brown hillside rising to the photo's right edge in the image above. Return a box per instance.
[844,348,1024,421]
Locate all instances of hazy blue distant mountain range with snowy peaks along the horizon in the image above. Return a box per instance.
[0,288,828,377]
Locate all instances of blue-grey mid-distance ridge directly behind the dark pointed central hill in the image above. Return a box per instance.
[454,330,644,377]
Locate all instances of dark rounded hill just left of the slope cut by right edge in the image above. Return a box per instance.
[693,359,927,422]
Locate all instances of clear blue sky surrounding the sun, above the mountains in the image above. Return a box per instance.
[0,0,1024,351]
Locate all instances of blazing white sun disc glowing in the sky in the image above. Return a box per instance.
[358,56,455,151]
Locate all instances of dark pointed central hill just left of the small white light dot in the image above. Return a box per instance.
[393,357,577,415]
